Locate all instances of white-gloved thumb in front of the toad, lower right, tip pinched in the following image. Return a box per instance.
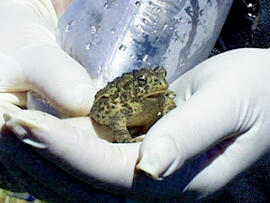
[137,85,237,180]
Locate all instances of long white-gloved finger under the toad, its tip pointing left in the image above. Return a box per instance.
[4,111,139,187]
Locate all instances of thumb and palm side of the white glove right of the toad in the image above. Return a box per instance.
[137,49,270,195]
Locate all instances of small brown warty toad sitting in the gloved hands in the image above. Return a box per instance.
[90,66,176,143]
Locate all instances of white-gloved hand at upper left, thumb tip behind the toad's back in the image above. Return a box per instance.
[0,0,96,116]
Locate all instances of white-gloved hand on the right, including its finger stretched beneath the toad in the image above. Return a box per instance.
[5,49,270,201]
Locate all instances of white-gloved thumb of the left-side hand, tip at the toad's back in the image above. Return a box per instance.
[16,45,96,116]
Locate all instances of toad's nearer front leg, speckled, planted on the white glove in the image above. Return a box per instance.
[111,112,134,143]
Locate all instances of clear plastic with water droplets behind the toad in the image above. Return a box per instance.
[59,0,233,87]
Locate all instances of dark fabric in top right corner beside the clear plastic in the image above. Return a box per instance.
[211,0,270,56]
